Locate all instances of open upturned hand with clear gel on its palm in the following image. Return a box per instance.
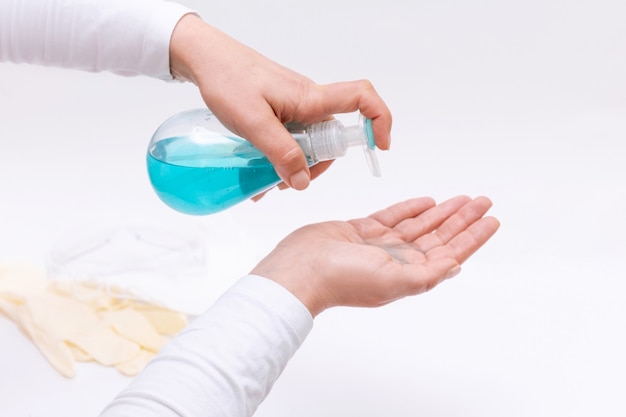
[252,196,500,317]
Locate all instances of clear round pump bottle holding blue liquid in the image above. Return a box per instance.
[147,109,380,215]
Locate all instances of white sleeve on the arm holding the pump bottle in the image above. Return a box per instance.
[0,0,191,80]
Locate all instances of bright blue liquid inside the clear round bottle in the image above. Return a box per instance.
[147,137,280,215]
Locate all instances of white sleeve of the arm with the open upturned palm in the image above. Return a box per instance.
[100,275,313,417]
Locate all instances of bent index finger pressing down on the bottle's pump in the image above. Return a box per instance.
[318,80,392,150]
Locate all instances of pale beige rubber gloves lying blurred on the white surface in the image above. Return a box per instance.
[0,262,187,378]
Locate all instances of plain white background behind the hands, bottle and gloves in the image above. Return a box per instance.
[0,0,626,417]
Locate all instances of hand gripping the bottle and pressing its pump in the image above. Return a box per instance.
[170,14,391,190]
